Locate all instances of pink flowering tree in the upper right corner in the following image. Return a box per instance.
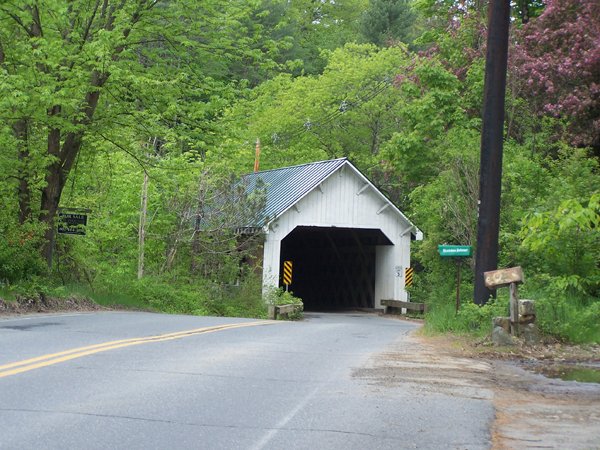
[511,0,600,152]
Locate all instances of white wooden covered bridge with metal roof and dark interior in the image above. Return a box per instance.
[243,158,422,310]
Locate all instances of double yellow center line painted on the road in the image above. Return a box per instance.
[0,321,276,378]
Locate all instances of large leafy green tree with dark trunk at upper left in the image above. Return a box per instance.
[0,0,282,268]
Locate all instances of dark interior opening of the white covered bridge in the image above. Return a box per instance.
[280,227,392,311]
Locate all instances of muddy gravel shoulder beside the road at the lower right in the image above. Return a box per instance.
[418,335,600,450]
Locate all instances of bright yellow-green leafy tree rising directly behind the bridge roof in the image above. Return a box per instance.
[213,44,408,171]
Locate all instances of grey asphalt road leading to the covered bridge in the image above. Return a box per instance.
[0,312,494,450]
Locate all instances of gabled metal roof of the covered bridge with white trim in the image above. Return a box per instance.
[241,158,422,239]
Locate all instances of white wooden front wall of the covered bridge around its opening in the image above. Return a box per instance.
[263,167,411,308]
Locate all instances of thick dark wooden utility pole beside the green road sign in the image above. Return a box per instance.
[474,0,510,305]
